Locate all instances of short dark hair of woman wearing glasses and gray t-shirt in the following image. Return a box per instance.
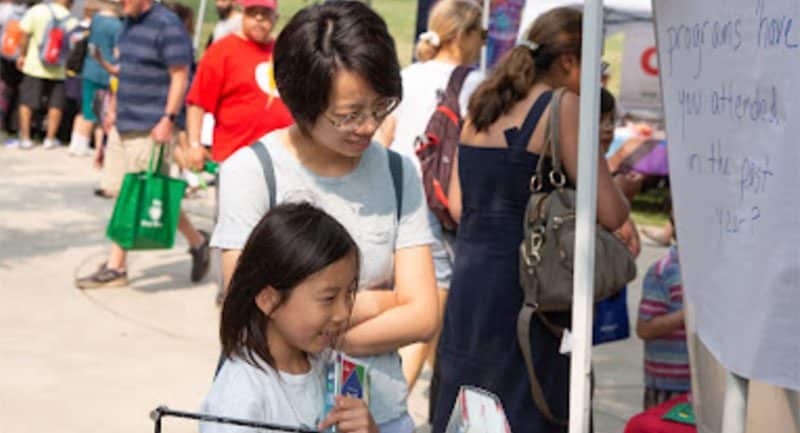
[274,1,403,132]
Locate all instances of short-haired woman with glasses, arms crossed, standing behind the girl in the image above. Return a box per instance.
[213,1,438,433]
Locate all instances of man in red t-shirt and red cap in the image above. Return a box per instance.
[185,0,293,166]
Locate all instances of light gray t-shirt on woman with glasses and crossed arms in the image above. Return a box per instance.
[211,130,433,424]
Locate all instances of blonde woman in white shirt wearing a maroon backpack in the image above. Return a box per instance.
[382,0,486,394]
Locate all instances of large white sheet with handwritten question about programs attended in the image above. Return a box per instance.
[654,0,800,390]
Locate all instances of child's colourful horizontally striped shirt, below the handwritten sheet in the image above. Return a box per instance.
[639,246,691,391]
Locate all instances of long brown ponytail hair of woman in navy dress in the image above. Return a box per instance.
[469,7,582,131]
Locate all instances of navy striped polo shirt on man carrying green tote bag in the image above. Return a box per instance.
[117,3,193,133]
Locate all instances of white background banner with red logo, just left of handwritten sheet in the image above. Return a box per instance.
[619,22,661,117]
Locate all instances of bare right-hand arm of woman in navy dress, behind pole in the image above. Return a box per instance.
[559,92,630,231]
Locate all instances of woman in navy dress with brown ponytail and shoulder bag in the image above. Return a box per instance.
[433,8,628,433]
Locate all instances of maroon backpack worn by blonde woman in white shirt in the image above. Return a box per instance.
[414,66,471,230]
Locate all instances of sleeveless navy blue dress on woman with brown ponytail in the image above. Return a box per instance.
[433,92,570,433]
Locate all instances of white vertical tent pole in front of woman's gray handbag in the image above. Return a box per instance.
[569,0,603,433]
